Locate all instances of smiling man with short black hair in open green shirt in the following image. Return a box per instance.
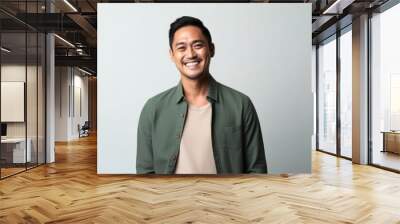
[136,16,267,174]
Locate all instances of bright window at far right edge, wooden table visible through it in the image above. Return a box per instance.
[370,4,400,170]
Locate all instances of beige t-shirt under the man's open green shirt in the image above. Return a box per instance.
[175,103,217,174]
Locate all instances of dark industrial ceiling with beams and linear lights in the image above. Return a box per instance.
[0,0,394,73]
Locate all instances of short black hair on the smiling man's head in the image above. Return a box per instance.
[169,16,212,49]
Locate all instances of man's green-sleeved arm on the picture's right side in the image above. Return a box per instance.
[244,99,267,173]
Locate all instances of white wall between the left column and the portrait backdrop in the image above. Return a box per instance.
[55,67,88,141]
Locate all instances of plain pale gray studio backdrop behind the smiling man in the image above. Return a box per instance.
[97,3,313,174]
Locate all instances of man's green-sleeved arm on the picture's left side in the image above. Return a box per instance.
[136,101,155,174]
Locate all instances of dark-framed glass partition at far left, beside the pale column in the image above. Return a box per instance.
[0,1,46,179]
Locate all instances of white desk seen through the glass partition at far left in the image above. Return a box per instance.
[1,138,32,163]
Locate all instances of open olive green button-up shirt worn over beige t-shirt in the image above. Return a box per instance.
[136,76,267,174]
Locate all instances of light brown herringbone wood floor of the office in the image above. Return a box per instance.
[0,134,400,224]
